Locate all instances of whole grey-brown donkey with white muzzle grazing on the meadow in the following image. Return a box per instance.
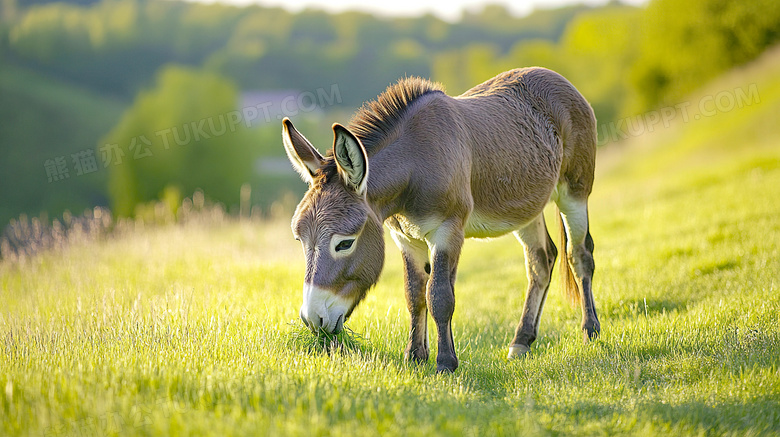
[282,67,600,372]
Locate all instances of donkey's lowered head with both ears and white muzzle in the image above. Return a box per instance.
[282,118,384,332]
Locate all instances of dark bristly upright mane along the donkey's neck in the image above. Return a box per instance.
[349,76,444,155]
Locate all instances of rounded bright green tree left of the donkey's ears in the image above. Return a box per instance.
[102,67,257,216]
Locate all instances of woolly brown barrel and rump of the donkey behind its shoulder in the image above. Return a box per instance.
[455,67,596,237]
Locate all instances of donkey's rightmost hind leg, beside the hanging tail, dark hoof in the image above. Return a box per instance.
[557,189,601,341]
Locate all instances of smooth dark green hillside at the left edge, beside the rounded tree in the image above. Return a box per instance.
[0,60,127,228]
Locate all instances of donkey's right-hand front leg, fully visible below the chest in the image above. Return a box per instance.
[426,224,463,372]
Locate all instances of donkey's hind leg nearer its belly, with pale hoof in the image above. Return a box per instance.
[507,214,558,359]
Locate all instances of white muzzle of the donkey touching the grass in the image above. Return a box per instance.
[300,284,350,334]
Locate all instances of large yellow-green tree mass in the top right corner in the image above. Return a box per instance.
[631,0,780,111]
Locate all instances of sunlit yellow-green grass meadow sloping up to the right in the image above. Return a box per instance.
[0,50,780,436]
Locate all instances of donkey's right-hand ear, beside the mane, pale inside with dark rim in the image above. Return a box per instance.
[333,123,368,196]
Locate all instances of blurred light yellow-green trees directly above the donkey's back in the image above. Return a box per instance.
[432,5,649,123]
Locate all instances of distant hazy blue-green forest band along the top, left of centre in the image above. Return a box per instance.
[4,0,585,106]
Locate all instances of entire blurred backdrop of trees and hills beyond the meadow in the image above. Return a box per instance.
[0,0,780,228]
